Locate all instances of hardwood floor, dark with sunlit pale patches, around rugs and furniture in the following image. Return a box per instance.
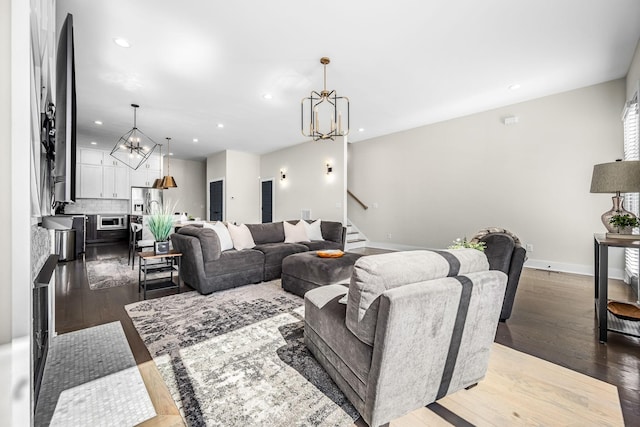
[55,244,640,427]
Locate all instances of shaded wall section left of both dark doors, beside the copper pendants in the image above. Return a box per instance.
[162,158,207,218]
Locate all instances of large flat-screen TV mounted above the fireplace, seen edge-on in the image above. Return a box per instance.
[52,14,76,205]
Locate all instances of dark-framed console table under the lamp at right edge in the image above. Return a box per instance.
[593,234,640,343]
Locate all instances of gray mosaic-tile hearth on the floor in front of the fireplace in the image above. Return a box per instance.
[34,322,156,427]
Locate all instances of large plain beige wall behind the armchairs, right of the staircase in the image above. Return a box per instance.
[348,79,625,273]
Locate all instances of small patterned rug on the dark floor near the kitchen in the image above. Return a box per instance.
[85,257,168,291]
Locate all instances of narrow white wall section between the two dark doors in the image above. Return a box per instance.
[225,150,261,224]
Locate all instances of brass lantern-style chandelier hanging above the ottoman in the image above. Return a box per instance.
[301,57,349,141]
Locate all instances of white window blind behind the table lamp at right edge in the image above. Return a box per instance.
[622,92,640,284]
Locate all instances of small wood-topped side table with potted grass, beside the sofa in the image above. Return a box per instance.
[138,249,182,299]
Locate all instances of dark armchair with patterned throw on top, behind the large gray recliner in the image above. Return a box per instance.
[471,227,527,322]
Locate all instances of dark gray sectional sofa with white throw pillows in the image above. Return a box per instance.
[171,220,346,294]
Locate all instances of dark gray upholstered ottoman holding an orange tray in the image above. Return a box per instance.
[282,252,362,297]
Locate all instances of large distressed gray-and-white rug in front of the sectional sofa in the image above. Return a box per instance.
[125,280,359,426]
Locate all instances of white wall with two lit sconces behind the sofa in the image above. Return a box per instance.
[260,138,346,222]
